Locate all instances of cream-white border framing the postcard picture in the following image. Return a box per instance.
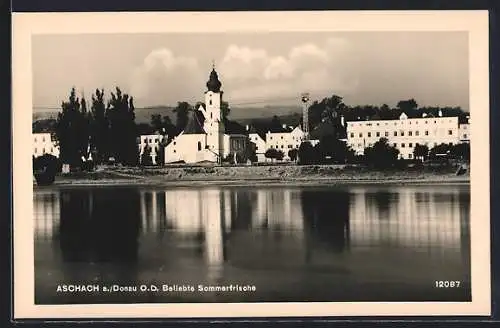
[12,11,491,319]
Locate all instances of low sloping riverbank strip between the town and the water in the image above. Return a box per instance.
[34,165,470,187]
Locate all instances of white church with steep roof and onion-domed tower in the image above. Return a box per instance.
[165,67,249,164]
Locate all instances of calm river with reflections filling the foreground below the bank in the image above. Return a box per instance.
[33,185,471,304]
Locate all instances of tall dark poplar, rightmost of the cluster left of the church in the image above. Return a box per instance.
[107,87,138,165]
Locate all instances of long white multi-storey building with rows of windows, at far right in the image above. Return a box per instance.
[347,113,461,159]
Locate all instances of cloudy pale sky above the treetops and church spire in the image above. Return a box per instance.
[32,32,469,111]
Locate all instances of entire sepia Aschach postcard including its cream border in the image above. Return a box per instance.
[13,11,490,318]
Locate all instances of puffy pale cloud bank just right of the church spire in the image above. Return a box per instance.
[218,38,356,102]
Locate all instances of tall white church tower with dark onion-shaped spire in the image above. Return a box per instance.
[203,65,225,162]
